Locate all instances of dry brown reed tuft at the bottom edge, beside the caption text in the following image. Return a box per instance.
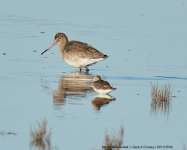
[105,126,124,150]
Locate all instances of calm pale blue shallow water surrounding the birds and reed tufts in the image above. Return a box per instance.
[0,0,187,150]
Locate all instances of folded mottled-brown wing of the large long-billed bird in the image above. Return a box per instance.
[65,41,106,59]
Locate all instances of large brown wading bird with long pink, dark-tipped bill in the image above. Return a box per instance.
[41,33,108,71]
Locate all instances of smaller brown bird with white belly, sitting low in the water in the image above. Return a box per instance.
[92,76,116,94]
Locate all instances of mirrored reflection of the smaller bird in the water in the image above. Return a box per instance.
[92,94,115,110]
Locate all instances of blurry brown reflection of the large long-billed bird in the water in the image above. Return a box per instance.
[53,71,94,106]
